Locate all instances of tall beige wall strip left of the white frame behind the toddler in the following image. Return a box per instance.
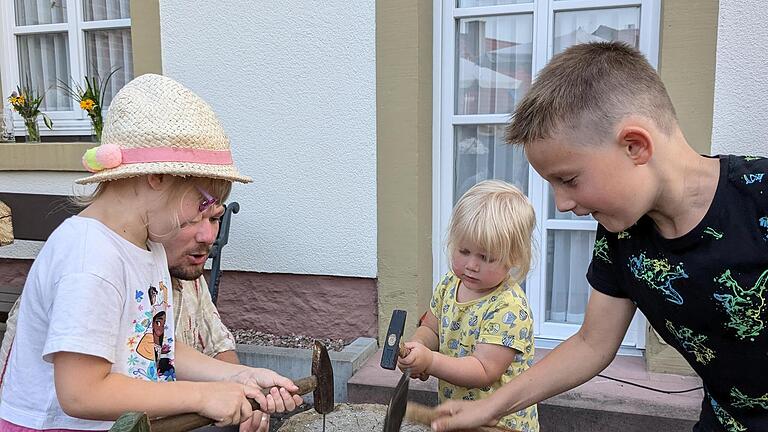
[376,0,432,342]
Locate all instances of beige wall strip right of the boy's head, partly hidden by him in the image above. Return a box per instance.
[645,0,719,374]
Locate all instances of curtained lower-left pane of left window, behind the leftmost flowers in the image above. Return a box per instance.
[16,32,72,111]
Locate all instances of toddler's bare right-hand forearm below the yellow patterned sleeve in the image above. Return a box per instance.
[427,343,517,388]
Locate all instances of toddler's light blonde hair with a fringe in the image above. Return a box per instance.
[447,180,536,282]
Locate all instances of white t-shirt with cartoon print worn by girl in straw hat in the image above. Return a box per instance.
[0,216,175,430]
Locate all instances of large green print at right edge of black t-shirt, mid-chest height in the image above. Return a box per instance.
[713,270,768,340]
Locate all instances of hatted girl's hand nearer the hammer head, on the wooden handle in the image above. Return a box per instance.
[230,367,304,413]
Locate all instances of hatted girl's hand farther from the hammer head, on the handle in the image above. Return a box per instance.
[197,381,258,427]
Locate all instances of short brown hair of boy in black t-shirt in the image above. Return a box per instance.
[506,42,677,145]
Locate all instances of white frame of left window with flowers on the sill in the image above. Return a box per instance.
[0,0,131,136]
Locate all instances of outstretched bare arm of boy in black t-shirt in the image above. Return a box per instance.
[433,289,635,431]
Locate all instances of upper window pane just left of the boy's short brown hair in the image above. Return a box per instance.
[455,14,533,115]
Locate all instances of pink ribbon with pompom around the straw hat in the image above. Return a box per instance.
[83,144,232,172]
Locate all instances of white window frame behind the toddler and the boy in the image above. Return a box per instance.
[432,0,661,354]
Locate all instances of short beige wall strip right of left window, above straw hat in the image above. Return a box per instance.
[131,0,163,76]
